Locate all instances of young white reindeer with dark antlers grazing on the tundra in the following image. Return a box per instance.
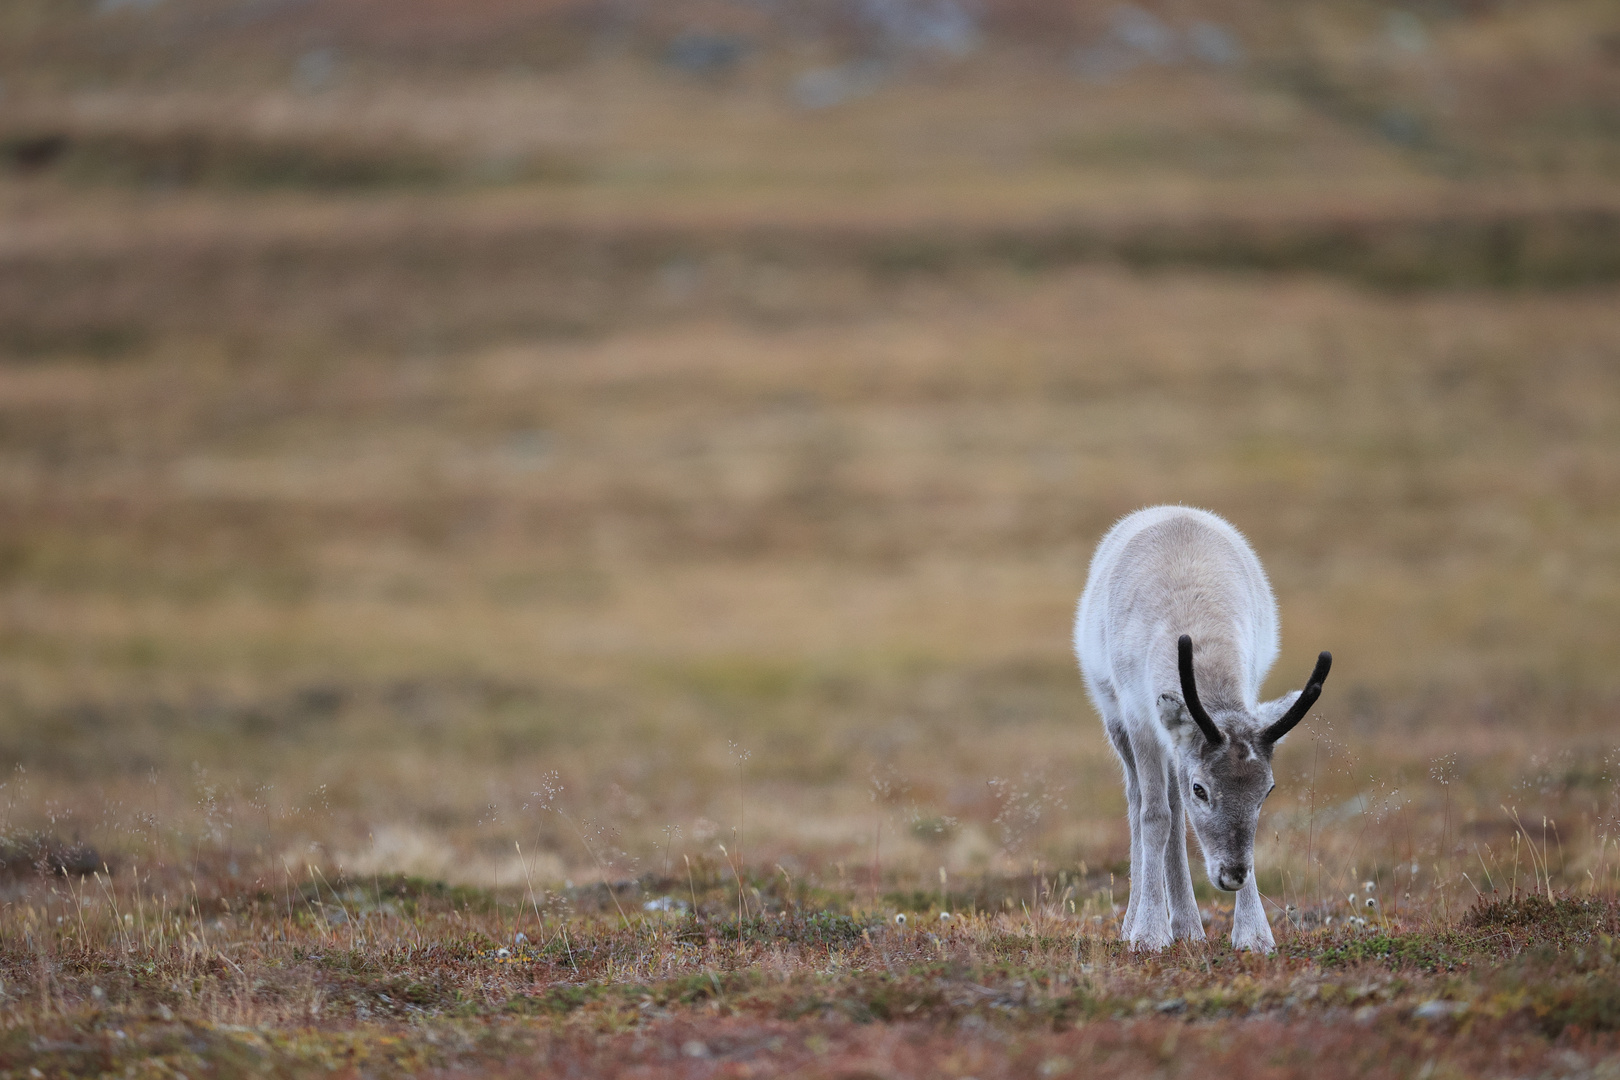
[1074,507,1333,952]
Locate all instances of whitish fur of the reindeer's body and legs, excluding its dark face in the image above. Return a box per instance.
[1074,507,1298,952]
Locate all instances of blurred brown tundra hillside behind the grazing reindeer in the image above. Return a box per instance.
[0,0,1620,899]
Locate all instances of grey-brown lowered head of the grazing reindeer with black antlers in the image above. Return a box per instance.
[1158,635,1333,892]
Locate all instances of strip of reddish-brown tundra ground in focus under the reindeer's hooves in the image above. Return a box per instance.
[0,865,1620,1077]
